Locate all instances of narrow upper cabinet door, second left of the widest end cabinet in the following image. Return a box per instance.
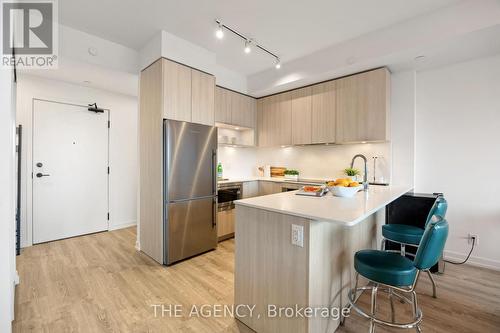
[291,87,312,145]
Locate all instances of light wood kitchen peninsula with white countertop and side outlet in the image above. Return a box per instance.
[235,186,410,333]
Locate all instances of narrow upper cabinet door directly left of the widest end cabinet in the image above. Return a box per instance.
[311,81,336,143]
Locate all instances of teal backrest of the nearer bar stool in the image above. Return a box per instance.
[413,215,448,270]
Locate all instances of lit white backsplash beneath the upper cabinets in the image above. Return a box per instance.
[218,143,391,181]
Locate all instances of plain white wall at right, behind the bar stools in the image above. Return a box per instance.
[415,56,500,269]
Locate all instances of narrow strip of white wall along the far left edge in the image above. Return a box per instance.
[0,69,16,332]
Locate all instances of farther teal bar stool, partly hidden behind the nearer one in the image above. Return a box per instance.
[381,196,448,298]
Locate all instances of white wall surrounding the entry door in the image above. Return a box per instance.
[17,75,137,246]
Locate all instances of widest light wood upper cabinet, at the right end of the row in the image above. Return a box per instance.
[336,68,390,143]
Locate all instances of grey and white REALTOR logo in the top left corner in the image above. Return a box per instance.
[1,0,58,69]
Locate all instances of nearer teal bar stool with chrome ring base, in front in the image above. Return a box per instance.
[348,215,448,333]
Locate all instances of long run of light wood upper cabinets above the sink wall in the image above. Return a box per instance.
[258,68,390,147]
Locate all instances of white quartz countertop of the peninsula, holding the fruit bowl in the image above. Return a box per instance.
[235,185,412,226]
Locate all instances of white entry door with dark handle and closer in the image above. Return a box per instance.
[33,100,109,244]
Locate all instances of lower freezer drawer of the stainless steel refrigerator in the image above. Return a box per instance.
[165,197,217,265]
